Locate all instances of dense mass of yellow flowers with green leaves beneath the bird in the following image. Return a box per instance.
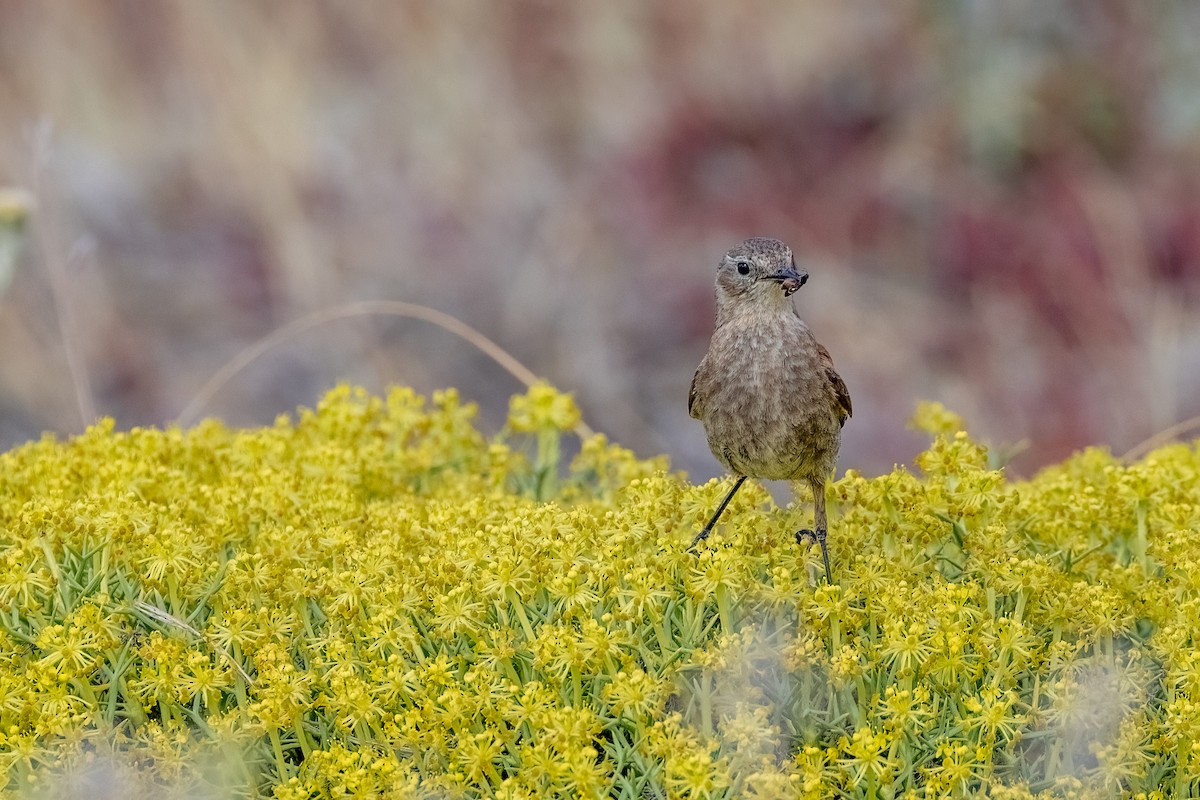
[0,386,1200,800]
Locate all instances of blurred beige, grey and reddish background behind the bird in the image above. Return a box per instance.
[0,0,1200,480]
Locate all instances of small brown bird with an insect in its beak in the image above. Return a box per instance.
[688,239,852,583]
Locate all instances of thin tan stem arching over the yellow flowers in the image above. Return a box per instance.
[175,300,593,438]
